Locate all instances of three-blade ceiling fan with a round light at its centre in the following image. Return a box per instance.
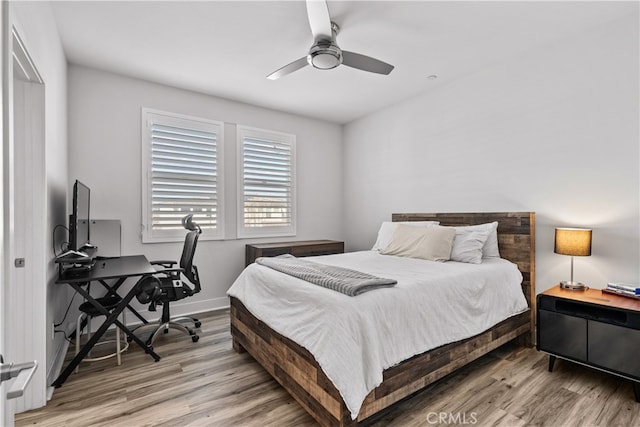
[267,0,393,80]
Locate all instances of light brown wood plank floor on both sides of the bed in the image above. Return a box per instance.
[16,311,640,427]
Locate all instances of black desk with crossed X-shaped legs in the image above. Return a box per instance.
[52,255,160,387]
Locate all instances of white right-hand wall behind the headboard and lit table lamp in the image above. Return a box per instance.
[344,14,640,292]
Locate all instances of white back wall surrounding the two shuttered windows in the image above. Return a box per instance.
[69,66,343,314]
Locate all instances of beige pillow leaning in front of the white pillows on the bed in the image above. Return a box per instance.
[381,224,456,261]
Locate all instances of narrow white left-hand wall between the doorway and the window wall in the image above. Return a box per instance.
[9,2,70,410]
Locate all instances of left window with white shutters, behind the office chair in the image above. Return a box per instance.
[142,108,224,243]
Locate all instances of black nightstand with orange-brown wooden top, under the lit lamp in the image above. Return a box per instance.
[536,286,640,402]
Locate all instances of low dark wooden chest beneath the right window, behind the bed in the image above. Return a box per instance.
[245,240,344,267]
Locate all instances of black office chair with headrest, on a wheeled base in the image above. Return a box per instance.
[136,214,202,345]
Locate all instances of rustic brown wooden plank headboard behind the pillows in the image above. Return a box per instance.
[391,212,536,324]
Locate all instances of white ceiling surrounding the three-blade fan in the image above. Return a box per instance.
[52,0,638,123]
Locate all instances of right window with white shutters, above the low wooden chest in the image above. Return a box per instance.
[237,126,296,237]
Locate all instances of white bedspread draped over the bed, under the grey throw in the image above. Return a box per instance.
[228,251,527,419]
